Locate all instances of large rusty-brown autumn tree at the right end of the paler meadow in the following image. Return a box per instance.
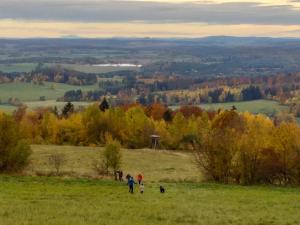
[196,110,244,183]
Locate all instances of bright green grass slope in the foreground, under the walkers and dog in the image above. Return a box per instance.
[0,176,300,225]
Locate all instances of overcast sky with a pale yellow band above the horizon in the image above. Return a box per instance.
[0,0,300,38]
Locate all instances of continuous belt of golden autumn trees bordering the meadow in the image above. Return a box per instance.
[0,101,300,184]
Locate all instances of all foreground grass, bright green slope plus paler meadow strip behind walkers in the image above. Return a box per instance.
[0,145,300,225]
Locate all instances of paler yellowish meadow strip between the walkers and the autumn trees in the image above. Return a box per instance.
[27,145,201,182]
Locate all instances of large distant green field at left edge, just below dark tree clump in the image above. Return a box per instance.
[0,82,98,101]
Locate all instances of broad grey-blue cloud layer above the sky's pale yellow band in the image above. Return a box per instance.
[0,0,300,25]
